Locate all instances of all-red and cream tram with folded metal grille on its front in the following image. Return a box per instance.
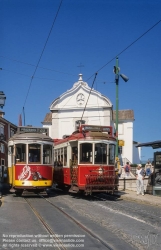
[54,124,118,194]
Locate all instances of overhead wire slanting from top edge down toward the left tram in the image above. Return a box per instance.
[23,0,63,109]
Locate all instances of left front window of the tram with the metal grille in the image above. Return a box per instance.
[80,143,92,163]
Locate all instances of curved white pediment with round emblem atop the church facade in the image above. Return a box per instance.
[50,74,112,111]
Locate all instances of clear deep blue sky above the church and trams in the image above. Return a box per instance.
[0,0,161,160]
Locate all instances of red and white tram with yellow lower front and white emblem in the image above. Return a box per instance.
[8,127,54,195]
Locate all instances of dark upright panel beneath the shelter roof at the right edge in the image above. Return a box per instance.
[153,152,161,196]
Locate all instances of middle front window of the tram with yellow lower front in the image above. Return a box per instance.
[28,144,41,163]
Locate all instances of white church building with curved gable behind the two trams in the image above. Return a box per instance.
[42,74,140,165]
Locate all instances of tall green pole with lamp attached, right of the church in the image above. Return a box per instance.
[113,57,129,168]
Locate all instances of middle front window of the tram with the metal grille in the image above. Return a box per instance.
[94,143,107,164]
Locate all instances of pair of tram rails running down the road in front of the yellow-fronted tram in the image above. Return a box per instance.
[24,194,113,250]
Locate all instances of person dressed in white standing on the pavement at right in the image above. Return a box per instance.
[136,164,145,195]
